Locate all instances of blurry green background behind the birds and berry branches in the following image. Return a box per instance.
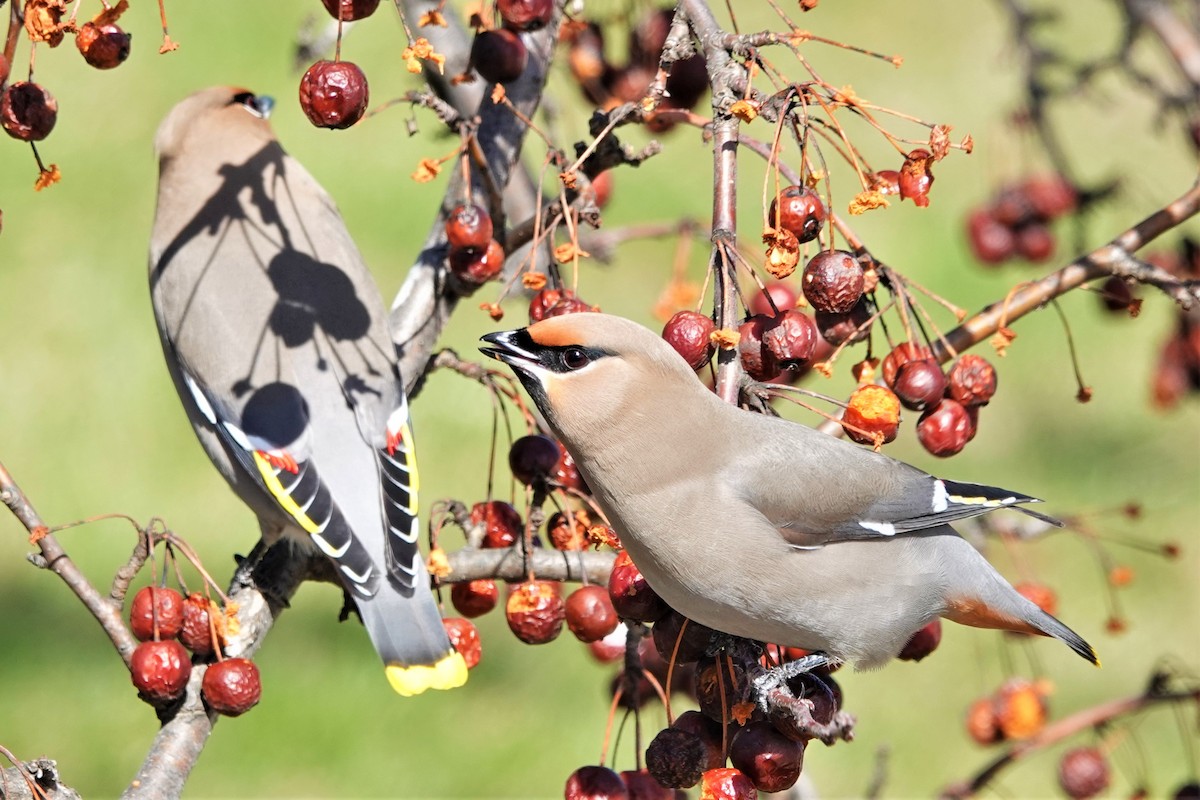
[0,0,1200,798]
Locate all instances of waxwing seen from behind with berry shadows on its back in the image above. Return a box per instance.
[149,86,467,696]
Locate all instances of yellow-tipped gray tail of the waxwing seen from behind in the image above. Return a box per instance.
[352,581,467,697]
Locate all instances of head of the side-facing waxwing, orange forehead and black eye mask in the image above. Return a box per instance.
[480,313,700,441]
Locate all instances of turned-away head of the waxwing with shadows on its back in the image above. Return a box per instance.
[155,86,275,166]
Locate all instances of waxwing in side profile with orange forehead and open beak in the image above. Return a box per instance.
[481,313,1097,668]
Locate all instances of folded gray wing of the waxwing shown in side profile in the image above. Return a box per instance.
[731,414,1054,546]
